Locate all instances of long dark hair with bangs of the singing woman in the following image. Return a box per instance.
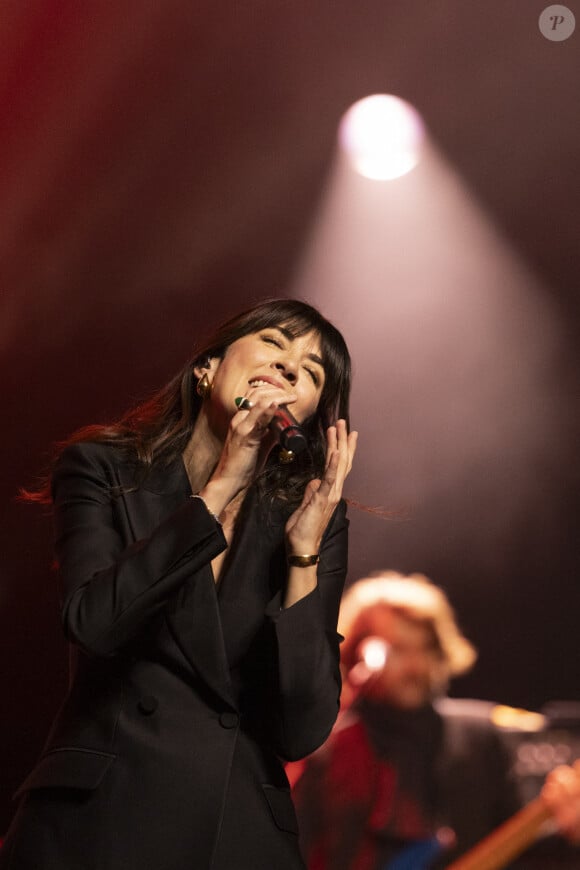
[21,299,351,504]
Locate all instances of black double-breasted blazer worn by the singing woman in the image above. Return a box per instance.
[0,443,348,870]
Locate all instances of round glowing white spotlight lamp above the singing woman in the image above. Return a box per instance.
[339,94,424,181]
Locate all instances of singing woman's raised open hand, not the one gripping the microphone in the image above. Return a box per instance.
[286,420,358,556]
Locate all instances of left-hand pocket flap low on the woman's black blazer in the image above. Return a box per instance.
[14,748,117,799]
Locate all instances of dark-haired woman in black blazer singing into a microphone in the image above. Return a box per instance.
[0,300,356,870]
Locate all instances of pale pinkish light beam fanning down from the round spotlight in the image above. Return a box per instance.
[291,131,571,584]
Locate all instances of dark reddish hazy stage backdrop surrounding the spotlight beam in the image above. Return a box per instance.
[0,0,580,831]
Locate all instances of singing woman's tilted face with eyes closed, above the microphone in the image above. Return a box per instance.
[199,326,325,436]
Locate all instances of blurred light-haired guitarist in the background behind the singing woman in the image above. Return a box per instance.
[289,572,580,870]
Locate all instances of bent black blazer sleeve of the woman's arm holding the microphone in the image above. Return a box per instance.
[52,443,226,656]
